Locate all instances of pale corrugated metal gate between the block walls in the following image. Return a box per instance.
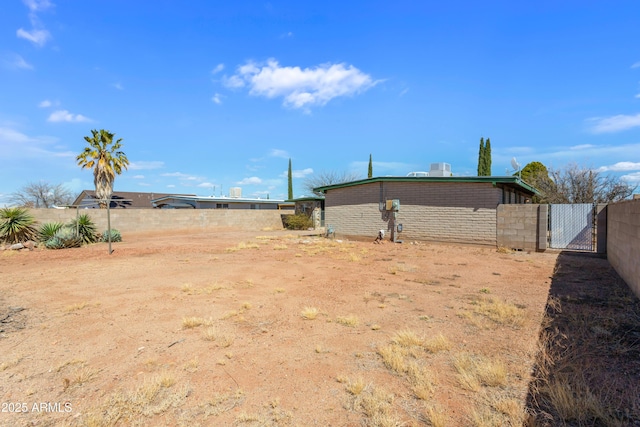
[549,203,595,251]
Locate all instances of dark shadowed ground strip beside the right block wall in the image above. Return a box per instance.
[525,252,640,426]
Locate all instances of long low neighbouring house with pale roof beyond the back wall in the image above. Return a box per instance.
[151,194,295,210]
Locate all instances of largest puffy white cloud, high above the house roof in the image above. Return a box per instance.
[225,59,378,111]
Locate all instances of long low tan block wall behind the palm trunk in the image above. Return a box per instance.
[31,209,292,233]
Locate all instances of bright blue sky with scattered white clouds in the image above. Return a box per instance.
[0,0,640,205]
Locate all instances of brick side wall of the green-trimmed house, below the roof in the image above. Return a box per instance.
[325,182,502,245]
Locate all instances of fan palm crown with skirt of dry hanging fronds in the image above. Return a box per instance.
[76,129,129,209]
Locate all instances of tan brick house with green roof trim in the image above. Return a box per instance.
[314,176,537,245]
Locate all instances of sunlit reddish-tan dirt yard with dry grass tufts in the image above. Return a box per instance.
[0,230,636,426]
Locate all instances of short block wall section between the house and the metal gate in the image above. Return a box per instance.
[496,205,546,251]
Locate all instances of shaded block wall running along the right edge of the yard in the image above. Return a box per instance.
[607,199,640,298]
